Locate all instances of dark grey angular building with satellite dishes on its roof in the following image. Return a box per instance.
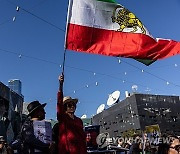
[92,93,180,137]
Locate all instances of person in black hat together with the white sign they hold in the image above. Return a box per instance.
[12,101,53,154]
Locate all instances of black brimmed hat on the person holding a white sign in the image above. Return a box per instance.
[27,101,46,116]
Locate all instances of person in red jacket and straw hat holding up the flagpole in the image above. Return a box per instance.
[57,74,87,154]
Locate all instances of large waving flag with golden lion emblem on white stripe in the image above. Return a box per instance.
[65,0,180,64]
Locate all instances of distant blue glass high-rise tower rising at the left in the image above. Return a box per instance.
[8,79,21,95]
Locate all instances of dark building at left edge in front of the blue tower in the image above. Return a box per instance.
[0,82,24,143]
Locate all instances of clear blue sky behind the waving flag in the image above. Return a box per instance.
[0,0,180,119]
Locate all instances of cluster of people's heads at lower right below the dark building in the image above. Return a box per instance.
[115,134,180,154]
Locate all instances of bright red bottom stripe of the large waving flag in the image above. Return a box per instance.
[66,24,180,60]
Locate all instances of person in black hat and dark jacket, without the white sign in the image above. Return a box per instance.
[12,101,53,154]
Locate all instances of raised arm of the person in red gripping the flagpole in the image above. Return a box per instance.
[57,73,65,120]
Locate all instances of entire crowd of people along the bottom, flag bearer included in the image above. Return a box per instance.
[0,74,180,154]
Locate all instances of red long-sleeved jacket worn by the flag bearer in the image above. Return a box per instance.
[57,92,87,154]
